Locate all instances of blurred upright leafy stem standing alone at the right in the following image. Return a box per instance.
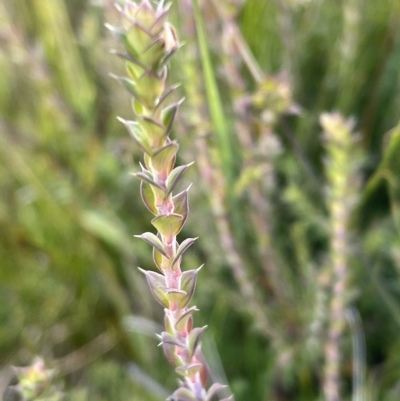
[320,113,357,401]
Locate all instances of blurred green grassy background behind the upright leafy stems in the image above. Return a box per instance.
[0,0,400,401]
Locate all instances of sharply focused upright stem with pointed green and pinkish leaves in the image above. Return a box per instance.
[108,0,231,401]
